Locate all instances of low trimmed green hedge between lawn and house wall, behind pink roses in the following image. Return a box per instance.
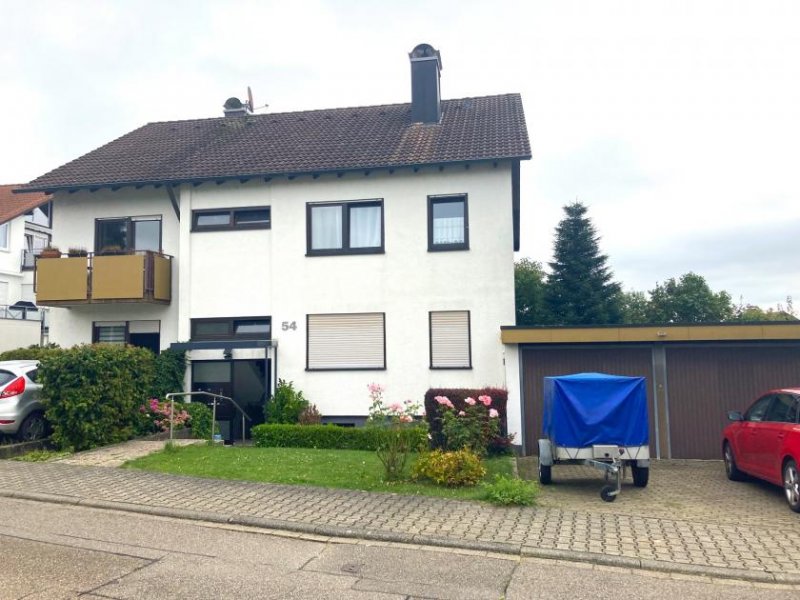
[251,424,428,450]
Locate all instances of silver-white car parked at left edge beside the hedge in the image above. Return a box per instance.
[0,360,48,441]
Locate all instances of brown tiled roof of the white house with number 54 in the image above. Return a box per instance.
[17,94,531,191]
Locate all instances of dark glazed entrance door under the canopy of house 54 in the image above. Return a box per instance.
[192,360,269,441]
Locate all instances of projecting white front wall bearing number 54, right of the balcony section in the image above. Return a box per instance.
[180,166,517,415]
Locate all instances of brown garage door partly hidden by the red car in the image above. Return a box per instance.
[667,345,800,458]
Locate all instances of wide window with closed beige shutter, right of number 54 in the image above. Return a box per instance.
[306,313,386,371]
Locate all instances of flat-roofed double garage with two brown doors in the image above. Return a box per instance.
[502,323,800,459]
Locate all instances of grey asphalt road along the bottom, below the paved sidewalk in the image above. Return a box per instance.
[0,498,800,600]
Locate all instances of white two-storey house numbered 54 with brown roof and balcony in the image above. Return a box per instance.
[14,44,531,435]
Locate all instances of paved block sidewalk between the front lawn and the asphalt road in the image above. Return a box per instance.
[0,454,800,584]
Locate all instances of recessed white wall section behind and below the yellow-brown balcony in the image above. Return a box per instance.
[50,187,179,348]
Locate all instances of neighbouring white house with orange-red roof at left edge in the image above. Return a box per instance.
[0,185,51,352]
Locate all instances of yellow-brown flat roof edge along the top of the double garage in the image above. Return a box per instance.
[500,321,800,344]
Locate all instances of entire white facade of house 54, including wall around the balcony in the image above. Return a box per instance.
[43,161,519,431]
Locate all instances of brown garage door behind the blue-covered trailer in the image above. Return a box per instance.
[522,346,655,456]
